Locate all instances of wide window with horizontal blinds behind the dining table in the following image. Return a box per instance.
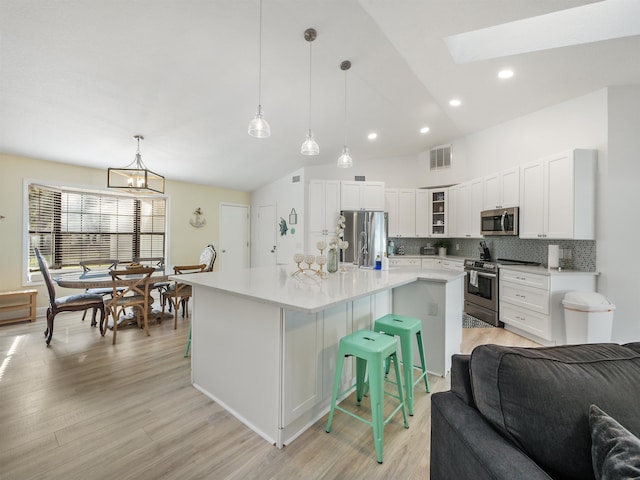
[28,184,166,272]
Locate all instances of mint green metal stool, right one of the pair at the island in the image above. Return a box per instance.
[373,313,431,415]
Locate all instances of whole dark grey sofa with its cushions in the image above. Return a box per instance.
[430,342,640,480]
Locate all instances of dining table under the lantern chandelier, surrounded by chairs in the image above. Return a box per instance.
[53,265,173,328]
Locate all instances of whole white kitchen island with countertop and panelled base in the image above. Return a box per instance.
[171,266,464,447]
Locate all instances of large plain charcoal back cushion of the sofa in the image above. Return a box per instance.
[470,344,640,479]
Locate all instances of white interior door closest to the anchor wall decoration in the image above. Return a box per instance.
[219,203,249,271]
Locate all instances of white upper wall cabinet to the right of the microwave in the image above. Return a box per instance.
[520,150,597,240]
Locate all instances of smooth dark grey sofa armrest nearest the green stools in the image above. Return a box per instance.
[430,391,551,480]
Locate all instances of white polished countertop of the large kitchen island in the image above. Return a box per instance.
[170,265,464,313]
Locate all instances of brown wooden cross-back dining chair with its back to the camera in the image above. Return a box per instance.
[105,267,155,345]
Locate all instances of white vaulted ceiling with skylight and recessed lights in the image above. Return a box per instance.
[0,0,640,191]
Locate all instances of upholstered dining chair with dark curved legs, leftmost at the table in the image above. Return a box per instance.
[34,248,105,346]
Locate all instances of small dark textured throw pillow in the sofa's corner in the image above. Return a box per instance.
[589,405,640,480]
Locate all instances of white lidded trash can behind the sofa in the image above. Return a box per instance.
[562,292,616,344]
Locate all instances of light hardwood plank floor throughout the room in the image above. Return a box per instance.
[0,306,535,480]
